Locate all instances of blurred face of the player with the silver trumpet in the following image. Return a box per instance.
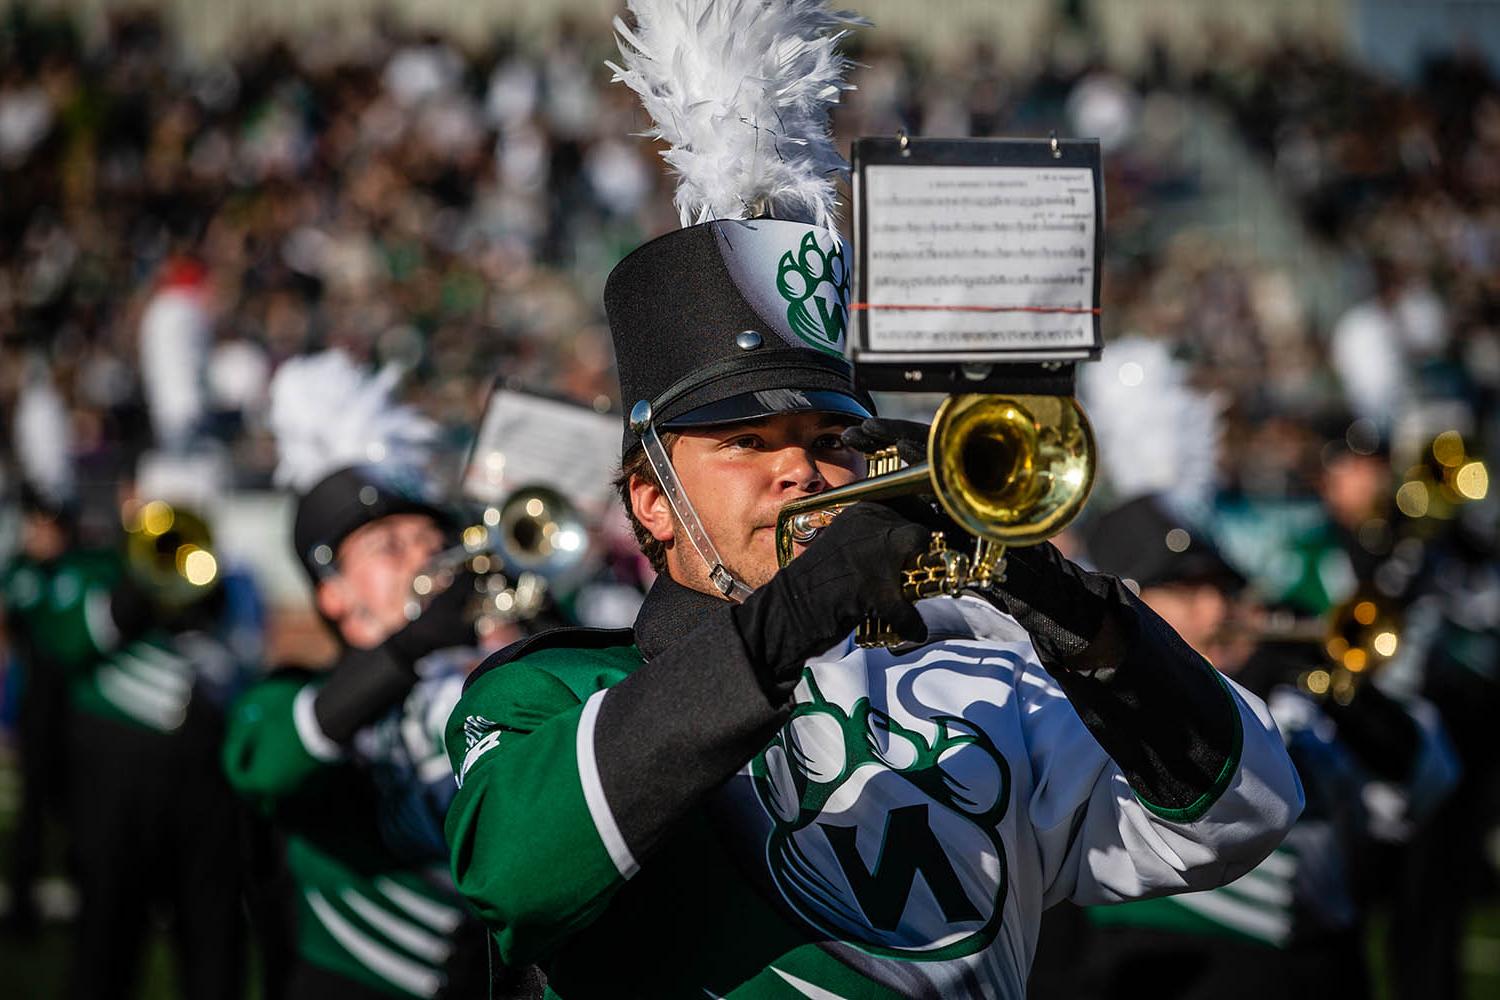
[320,514,443,648]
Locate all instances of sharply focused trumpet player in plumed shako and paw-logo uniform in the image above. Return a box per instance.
[446,3,1302,1000]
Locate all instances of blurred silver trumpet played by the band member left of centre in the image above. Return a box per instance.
[407,486,588,639]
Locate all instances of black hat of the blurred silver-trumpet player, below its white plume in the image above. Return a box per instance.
[293,465,461,585]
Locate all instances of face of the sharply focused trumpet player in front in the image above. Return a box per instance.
[638,414,864,592]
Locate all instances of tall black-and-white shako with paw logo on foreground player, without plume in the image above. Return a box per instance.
[605,219,875,453]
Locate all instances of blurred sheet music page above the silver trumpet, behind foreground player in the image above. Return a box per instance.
[464,390,620,513]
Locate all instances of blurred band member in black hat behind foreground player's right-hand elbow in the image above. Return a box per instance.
[1070,496,1455,1000]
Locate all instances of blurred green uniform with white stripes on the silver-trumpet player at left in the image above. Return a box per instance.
[224,655,473,997]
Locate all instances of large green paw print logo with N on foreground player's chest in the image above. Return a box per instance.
[752,673,1011,961]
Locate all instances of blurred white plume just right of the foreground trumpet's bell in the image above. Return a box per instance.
[1079,337,1223,517]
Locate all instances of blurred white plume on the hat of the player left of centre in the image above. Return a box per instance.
[270,349,438,493]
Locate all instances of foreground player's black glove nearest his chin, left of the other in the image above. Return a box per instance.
[731,504,929,690]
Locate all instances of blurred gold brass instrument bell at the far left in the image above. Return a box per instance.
[122,499,219,610]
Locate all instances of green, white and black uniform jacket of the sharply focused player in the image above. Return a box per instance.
[447,577,1302,1000]
